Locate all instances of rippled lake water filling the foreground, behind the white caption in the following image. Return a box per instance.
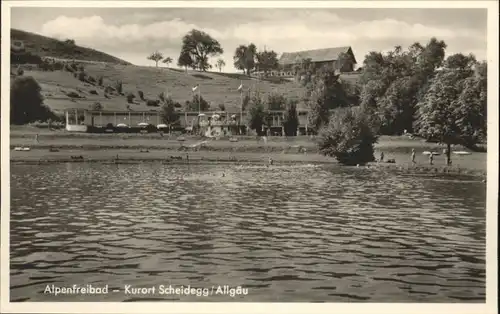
[10,163,486,302]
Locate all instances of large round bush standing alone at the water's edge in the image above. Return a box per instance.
[318,108,377,165]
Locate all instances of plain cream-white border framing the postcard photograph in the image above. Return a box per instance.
[0,1,499,314]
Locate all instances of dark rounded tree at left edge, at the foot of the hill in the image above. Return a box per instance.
[10,76,58,124]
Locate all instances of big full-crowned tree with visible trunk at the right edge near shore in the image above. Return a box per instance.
[415,55,487,161]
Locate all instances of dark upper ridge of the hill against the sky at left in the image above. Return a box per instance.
[10,29,130,64]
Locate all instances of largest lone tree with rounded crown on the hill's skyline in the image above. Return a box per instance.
[181,29,224,71]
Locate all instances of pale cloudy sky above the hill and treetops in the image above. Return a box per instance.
[11,7,487,72]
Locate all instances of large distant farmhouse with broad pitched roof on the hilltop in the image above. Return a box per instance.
[275,46,357,76]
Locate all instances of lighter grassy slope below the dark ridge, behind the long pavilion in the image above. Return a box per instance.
[24,64,305,112]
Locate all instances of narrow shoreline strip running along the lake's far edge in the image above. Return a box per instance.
[10,148,486,178]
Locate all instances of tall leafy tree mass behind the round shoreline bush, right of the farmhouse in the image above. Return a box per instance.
[359,38,446,135]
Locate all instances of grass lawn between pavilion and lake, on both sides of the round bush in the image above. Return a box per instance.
[10,126,486,173]
